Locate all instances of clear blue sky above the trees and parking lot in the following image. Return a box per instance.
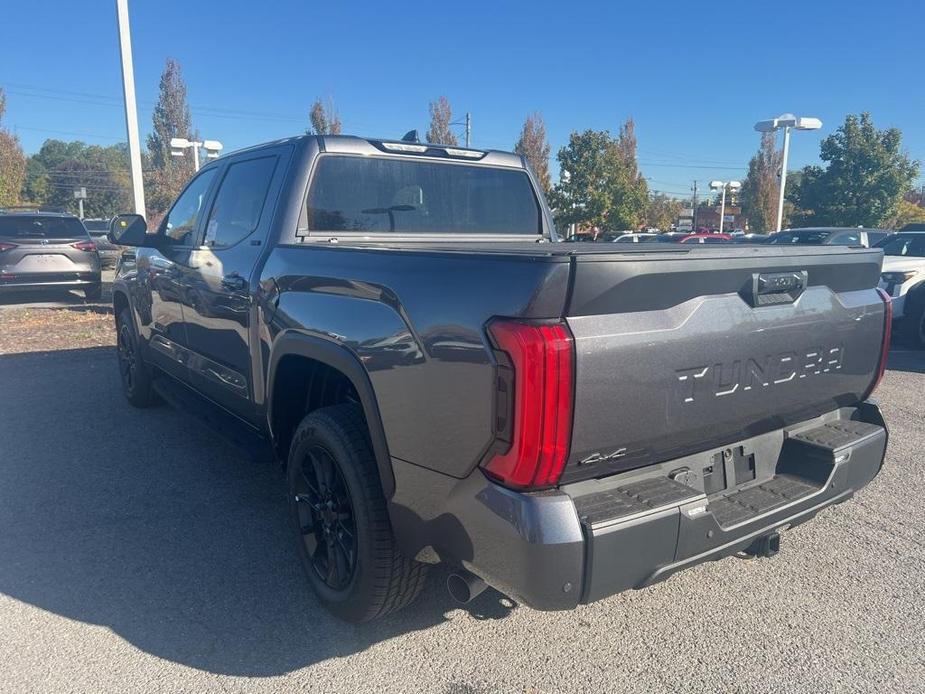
[0,0,925,195]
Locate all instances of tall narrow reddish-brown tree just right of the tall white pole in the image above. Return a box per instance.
[146,58,199,216]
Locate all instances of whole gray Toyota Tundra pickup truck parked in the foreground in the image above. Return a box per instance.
[110,136,890,621]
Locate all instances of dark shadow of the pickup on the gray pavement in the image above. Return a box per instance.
[0,348,512,676]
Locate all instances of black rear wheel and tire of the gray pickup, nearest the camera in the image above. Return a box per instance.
[287,404,427,623]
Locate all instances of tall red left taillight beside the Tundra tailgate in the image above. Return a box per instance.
[485,320,574,488]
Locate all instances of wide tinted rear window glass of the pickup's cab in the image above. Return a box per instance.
[307,156,541,234]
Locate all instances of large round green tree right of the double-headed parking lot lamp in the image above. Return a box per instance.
[788,113,919,227]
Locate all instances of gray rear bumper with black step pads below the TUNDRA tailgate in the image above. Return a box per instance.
[393,403,887,610]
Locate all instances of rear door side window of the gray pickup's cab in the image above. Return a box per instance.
[205,157,277,247]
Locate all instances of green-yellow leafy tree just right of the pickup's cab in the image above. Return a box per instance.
[550,121,648,230]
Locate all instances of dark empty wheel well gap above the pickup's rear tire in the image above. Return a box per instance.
[271,355,360,460]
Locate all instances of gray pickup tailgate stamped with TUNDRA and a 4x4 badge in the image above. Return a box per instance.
[562,247,885,482]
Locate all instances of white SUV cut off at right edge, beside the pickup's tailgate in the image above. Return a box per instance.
[877,231,925,347]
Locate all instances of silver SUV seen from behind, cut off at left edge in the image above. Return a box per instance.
[0,211,102,301]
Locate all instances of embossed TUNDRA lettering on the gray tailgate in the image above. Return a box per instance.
[675,345,845,404]
